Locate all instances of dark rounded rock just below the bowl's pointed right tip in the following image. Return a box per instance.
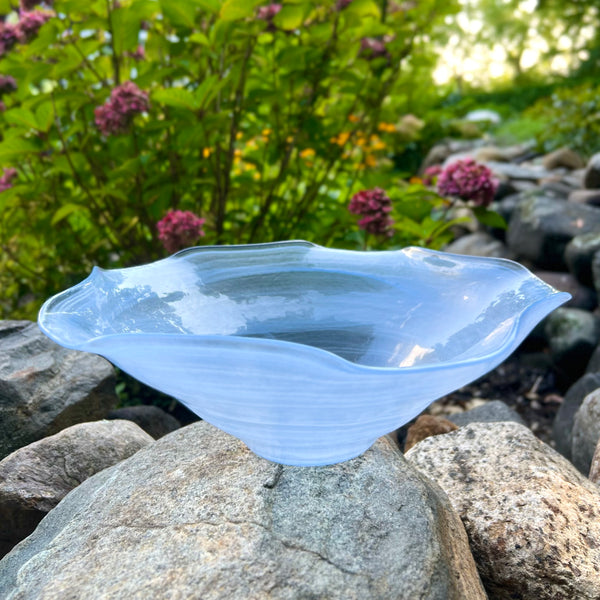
[544,307,600,381]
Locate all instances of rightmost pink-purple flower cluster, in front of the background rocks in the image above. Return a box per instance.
[437,158,498,206]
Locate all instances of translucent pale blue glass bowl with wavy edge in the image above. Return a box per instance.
[39,241,570,465]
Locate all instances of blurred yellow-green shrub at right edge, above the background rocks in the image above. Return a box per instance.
[525,83,600,156]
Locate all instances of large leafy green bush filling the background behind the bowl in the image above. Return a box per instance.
[0,0,457,317]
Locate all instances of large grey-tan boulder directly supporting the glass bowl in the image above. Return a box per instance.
[0,422,485,600]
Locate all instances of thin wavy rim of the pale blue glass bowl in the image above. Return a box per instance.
[38,240,571,373]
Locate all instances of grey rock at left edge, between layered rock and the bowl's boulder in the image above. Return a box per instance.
[0,421,154,556]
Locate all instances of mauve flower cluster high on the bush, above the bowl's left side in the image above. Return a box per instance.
[94,81,150,136]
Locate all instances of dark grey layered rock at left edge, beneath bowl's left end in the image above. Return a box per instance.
[0,321,117,459]
